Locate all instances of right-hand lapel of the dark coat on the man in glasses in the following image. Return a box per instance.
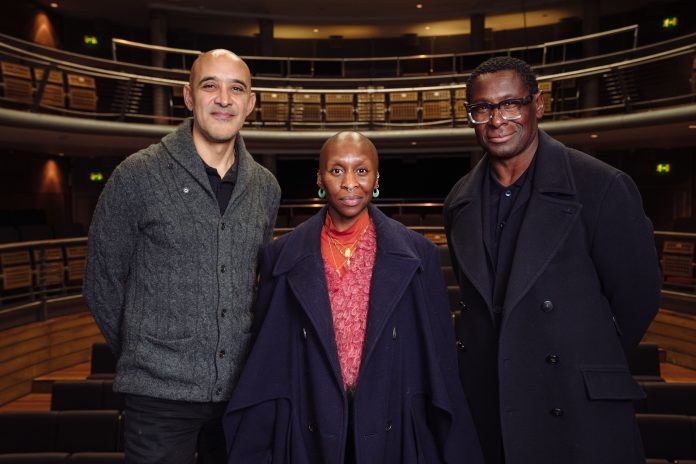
[504,130,582,311]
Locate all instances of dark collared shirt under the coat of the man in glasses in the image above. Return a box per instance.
[483,158,536,323]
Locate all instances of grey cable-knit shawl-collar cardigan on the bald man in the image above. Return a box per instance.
[84,120,280,402]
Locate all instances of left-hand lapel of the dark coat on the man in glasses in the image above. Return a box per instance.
[448,159,493,309]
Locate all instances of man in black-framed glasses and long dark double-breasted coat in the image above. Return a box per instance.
[445,57,660,464]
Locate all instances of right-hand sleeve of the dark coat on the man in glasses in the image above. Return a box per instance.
[591,173,661,353]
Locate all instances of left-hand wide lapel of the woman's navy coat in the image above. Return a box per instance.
[273,209,343,389]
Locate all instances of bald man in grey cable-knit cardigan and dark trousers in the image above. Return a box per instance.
[84,50,280,464]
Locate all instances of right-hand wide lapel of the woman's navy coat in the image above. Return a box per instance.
[363,205,422,365]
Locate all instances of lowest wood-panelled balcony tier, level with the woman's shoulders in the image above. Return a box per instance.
[0,218,696,330]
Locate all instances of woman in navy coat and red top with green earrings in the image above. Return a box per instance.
[224,132,482,464]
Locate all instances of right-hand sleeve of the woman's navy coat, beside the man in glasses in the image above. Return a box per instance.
[424,248,483,464]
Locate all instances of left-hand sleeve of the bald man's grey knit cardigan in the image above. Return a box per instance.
[83,165,138,356]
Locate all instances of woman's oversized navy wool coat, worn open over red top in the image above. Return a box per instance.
[224,206,482,464]
